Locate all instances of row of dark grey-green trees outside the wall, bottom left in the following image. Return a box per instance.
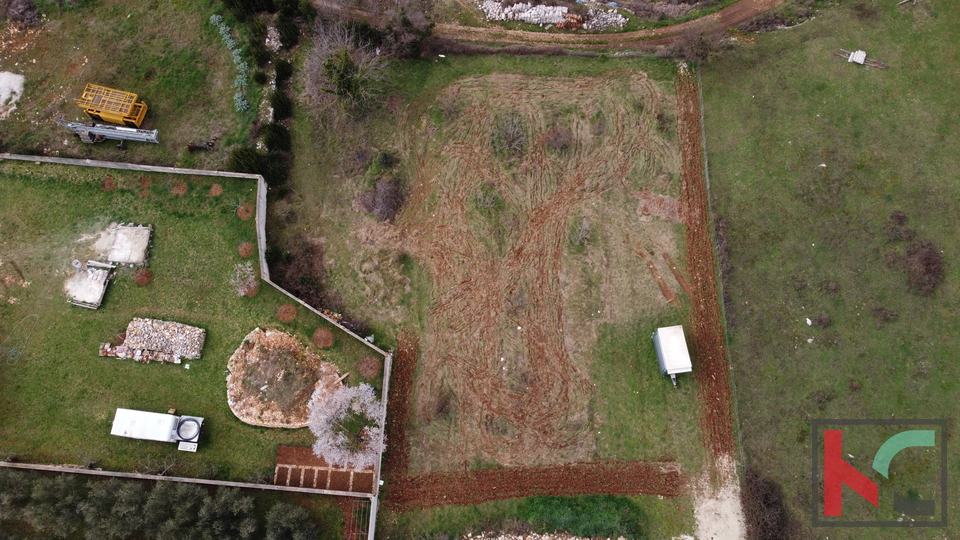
[0,468,320,540]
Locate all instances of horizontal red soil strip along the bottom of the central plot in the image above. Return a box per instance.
[384,461,685,511]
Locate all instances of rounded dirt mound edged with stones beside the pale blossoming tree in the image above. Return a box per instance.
[227,328,342,428]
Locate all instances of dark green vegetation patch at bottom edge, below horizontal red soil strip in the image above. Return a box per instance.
[520,495,644,538]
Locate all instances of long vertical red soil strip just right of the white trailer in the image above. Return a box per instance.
[676,67,736,457]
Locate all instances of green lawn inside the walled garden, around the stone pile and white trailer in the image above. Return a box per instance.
[0,161,378,480]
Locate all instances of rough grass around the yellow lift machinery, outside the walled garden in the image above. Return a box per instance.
[0,0,260,168]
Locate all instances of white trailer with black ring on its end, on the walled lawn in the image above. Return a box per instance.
[110,409,203,452]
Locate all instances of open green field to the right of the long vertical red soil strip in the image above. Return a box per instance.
[703,2,960,538]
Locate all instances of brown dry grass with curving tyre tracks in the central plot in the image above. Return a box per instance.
[383,72,679,472]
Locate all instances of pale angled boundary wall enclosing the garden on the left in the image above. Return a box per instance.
[0,153,393,540]
